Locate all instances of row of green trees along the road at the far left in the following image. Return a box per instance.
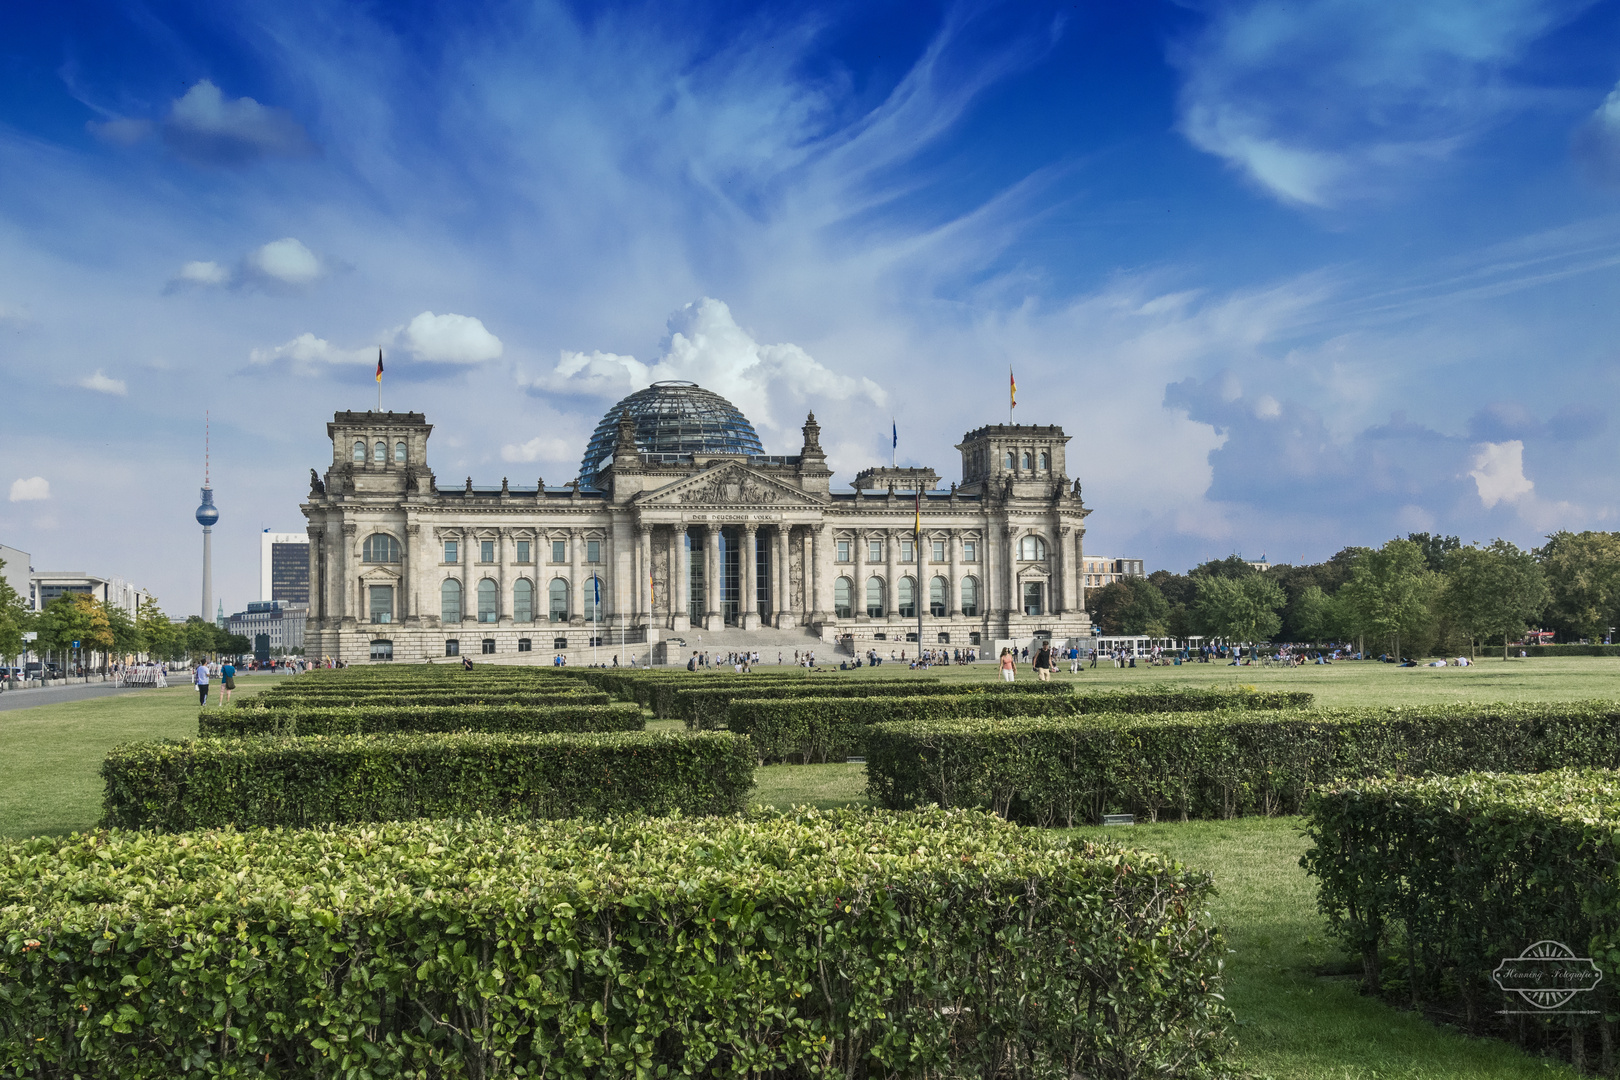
[0,559,253,665]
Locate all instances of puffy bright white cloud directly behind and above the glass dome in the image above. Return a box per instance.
[535,296,888,443]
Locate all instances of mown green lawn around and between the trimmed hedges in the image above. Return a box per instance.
[0,657,1620,1080]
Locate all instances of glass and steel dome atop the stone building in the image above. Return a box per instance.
[580,382,765,481]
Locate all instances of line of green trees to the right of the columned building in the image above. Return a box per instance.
[1085,533,1620,656]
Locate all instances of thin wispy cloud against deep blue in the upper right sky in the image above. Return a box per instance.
[1171,0,1586,206]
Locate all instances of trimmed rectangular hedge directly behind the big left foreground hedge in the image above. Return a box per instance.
[102,732,753,832]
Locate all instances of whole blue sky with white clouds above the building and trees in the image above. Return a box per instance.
[0,0,1620,614]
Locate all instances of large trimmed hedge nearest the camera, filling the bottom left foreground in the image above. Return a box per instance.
[0,811,1230,1080]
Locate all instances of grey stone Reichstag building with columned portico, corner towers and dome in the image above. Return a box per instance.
[303,382,1090,664]
